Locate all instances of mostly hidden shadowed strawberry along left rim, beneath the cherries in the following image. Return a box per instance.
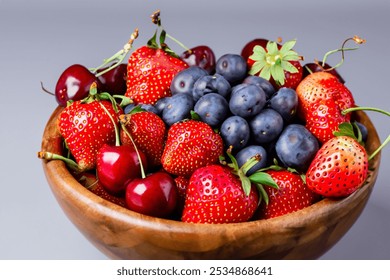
[78,172,126,207]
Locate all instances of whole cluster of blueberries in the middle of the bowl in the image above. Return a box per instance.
[125,54,319,174]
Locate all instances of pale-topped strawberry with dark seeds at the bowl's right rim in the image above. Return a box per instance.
[306,136,368,197]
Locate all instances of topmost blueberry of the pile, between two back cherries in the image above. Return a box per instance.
[215,54,247,85]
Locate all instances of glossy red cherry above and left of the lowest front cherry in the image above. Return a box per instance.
[96,145,147,194]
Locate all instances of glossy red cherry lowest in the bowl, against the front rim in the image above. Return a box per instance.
[125,171,178,218]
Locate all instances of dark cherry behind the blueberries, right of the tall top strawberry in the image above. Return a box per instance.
[180,45,216,74]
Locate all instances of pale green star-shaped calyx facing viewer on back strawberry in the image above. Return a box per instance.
[249,40,302,85]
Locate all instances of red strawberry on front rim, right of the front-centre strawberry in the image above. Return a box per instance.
[256,170,319,219]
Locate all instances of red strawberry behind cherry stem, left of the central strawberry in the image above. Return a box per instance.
[120,111,166,167]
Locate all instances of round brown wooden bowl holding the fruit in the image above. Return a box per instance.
[42,108,380,259]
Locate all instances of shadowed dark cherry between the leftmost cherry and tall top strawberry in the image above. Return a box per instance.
[97,63,127,95]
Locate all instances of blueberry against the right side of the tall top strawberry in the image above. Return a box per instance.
[170,66,208,95]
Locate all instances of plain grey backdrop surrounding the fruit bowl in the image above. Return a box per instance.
[0,0,390,259]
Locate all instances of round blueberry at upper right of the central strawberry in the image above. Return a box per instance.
[220,116,250,152]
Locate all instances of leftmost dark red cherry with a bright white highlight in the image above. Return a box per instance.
[55,64,100,107]
